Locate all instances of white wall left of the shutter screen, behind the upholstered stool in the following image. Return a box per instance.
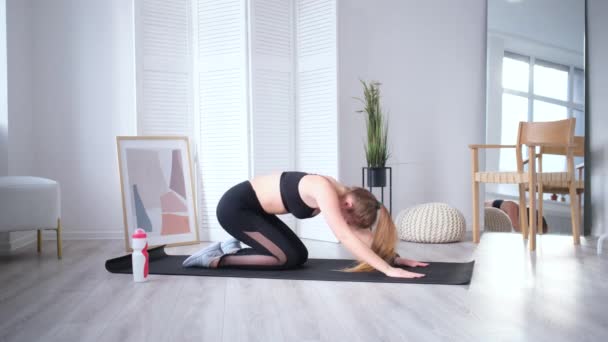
[2,0,136,247]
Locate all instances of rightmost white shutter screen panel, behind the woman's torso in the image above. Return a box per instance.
[296,0,338,241]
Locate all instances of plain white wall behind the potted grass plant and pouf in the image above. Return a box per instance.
[338,0,486,226]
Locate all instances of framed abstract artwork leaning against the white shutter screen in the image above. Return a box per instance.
[116,136,199,252]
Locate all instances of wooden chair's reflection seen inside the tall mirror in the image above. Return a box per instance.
[524,136,585,240]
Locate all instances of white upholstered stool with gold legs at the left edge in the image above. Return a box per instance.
[0,177,61,259]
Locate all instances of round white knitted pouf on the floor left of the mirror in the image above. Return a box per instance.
[395,203,466,243]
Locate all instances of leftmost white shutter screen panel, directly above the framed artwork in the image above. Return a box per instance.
[135,0,194,137]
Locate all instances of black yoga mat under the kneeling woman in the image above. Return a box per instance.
[106,246,475,285]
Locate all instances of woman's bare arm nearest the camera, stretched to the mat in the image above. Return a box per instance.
[313,178,423,278]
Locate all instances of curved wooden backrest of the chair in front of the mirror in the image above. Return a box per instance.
[516,118,576,172]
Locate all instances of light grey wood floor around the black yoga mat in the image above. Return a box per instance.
[0,233,608,342]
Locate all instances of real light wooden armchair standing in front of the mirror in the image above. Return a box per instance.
[469,118,579,251]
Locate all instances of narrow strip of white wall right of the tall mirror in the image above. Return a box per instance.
[587,0,608,235]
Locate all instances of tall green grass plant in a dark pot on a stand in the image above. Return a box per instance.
[357,80,390,187]
